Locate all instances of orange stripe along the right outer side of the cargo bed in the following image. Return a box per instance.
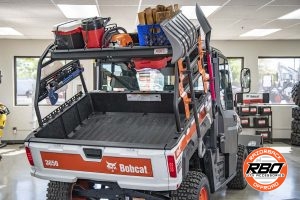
[175,107,207,159]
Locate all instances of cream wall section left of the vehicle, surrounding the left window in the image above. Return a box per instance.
[0,39,92,140]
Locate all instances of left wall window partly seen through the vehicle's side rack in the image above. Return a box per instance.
[14,57,65,105]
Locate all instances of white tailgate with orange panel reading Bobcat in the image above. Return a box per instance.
[25,142,181,191]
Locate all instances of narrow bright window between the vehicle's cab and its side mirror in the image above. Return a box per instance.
[227,57,244,95]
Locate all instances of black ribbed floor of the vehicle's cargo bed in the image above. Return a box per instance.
[69,113,179,145]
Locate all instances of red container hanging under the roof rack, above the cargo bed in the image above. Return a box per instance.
[133,57,171,69]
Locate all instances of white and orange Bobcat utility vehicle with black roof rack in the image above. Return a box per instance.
[25,5,250,200]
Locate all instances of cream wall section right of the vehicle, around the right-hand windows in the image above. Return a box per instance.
[212,40,300,138]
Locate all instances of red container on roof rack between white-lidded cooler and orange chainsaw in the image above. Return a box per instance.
[82,27,104,48]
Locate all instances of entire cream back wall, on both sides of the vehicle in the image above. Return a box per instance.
[0,40,300,140]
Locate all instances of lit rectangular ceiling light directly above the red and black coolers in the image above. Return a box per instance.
[57,4,99,19]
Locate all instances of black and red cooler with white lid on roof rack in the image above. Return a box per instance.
[52,20,84,49]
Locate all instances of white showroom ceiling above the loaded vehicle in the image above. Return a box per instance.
[0,0,300,40]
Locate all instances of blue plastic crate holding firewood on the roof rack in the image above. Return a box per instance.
[137,24,170,46]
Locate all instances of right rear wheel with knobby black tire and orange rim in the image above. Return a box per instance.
[171,171,210,200]
